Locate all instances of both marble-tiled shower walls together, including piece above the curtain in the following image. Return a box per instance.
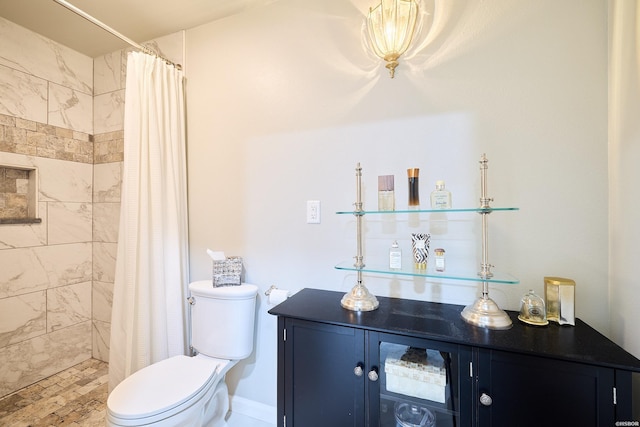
[0,17,182,397]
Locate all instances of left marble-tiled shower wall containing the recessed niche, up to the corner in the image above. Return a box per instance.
[0,18,94,396]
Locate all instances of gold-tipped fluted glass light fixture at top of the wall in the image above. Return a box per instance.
[367,0,418,78]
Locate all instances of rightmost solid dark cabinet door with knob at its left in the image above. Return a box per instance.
[476,349,615,427]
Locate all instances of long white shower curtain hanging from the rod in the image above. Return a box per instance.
[109,52,188,390]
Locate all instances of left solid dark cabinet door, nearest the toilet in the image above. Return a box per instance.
[278,319,366,427]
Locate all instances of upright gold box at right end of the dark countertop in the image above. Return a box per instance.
[544,277,576,325]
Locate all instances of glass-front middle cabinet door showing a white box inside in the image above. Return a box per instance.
[367,333,473,427]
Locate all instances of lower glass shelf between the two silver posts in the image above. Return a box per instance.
[335,261,520,285]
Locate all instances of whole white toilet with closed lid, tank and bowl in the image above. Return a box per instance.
[106,280,258,427]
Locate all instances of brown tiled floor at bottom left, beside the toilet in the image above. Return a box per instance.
[0,359,109,427]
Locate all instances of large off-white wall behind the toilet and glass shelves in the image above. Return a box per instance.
[186,0,610,414]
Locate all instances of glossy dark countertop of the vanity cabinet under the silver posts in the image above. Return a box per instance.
[269,289,640,372]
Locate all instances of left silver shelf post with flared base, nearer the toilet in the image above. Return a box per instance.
[340,163,379,311]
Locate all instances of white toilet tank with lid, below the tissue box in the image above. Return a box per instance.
[189,280,258,360]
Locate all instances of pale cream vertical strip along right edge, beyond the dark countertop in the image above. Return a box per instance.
[609,0,640,419]
